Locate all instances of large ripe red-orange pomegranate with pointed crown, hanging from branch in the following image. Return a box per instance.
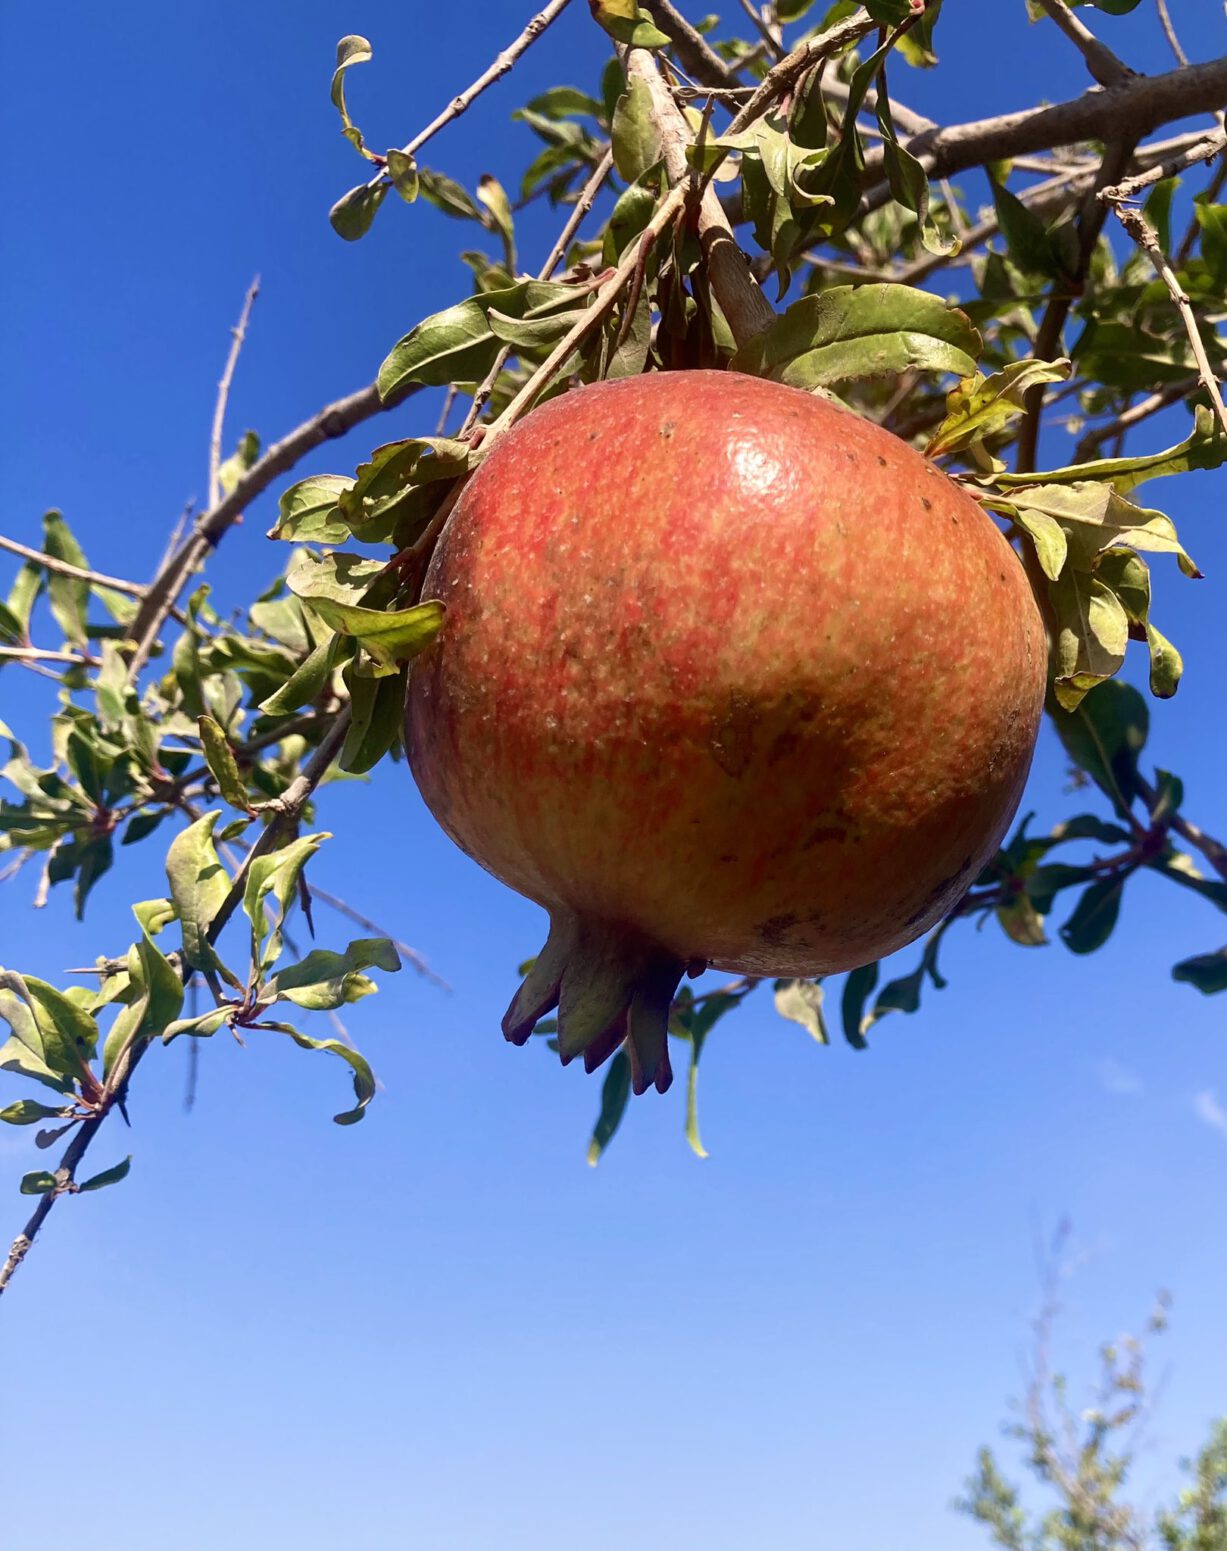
[405,371,1046,1092]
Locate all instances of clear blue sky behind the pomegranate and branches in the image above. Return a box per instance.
[0,0,1227,1551]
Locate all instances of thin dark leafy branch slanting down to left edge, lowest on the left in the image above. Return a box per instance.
[0,706,349,1295]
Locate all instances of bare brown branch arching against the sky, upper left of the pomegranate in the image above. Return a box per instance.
[127,383,417,679]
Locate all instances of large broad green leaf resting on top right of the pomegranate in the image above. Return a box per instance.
[731,284,982,391]
